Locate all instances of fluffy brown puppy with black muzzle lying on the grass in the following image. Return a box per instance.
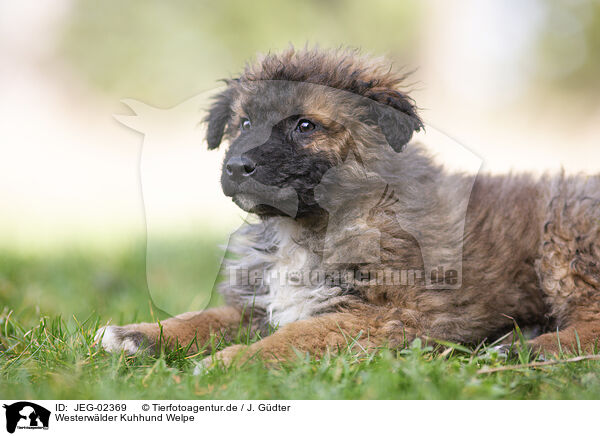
[98,49,600,363]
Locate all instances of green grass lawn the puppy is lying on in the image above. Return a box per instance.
[0,241,600,399]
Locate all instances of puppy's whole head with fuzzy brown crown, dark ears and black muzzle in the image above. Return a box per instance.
[206,49,422,218]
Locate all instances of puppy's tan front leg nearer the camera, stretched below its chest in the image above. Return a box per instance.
[201,313,396,367]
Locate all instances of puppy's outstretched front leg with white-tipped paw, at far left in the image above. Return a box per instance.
[95,306,243,354]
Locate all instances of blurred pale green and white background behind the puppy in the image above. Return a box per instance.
[0,0,600,323]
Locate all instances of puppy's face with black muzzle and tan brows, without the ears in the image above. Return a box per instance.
[221,81,350,218]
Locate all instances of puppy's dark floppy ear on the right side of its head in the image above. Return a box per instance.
[368,89,424,152]
